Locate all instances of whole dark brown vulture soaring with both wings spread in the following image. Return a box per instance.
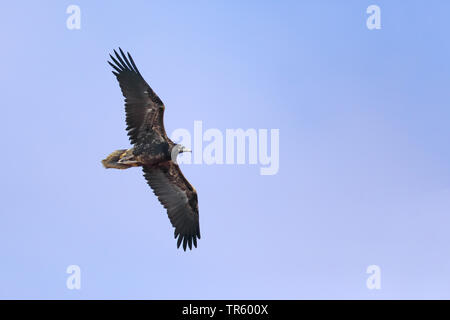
[102,47,200,251]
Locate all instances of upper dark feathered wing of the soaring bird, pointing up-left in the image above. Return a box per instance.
[108,48,167,144]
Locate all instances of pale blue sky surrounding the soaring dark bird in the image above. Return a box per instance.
[0,0,450,299]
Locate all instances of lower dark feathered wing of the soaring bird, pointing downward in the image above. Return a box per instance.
[143,160,200,251]
